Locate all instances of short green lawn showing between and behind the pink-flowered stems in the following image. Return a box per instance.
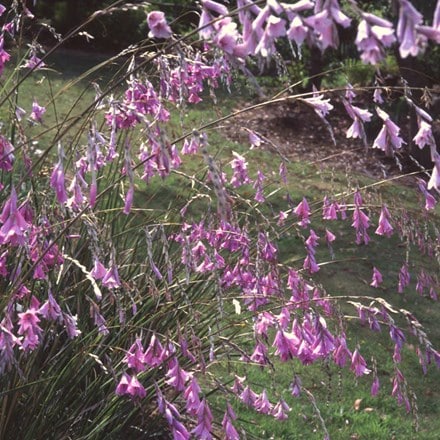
[4,50,440,440]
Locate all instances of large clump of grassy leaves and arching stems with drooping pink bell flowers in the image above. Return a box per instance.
[0,0,440,439]
